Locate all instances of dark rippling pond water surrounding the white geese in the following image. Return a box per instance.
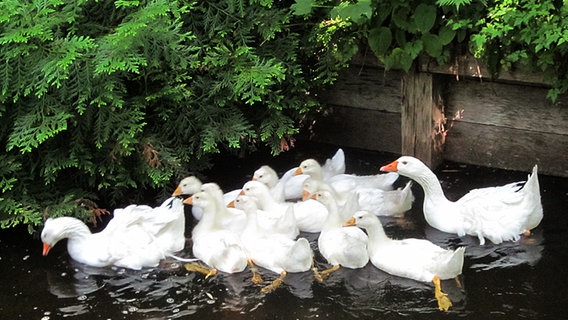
[0,142,568,319]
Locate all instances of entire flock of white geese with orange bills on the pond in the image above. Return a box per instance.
[41,149,543,310]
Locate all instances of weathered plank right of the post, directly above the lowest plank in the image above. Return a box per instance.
[446,80,568,135]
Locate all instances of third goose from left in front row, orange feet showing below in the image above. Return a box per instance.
[234,195,314,292]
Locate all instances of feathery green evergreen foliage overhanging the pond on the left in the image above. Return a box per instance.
[0,0,341,232]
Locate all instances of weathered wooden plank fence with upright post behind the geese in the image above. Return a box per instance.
[312,53,568,177]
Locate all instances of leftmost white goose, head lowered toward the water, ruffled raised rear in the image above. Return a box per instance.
[41,197,191,270]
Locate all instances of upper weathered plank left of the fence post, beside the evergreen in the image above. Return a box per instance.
[320,67,401,112]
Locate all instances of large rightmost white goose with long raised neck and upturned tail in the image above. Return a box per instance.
[381,156,543,245]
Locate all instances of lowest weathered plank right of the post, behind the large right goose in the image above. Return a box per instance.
[444,121,568,177]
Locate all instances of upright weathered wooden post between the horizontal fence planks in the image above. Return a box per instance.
[401,73,445,169]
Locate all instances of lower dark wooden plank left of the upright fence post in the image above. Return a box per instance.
[309,106,400,154]
